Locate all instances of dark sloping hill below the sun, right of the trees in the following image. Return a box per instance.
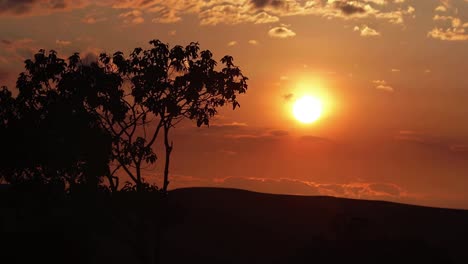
[161,188,468,263]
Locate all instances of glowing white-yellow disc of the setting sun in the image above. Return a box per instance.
[293,95,322,124]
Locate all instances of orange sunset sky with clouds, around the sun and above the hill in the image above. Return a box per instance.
[0,0,468,209]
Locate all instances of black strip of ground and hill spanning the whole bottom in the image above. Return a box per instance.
[0,188,468,263]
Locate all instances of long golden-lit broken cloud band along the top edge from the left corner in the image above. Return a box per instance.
[0,0,414,30]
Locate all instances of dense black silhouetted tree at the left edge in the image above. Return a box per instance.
[0,50,111,190]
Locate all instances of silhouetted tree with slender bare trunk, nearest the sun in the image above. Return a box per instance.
[100,40,247,192]
